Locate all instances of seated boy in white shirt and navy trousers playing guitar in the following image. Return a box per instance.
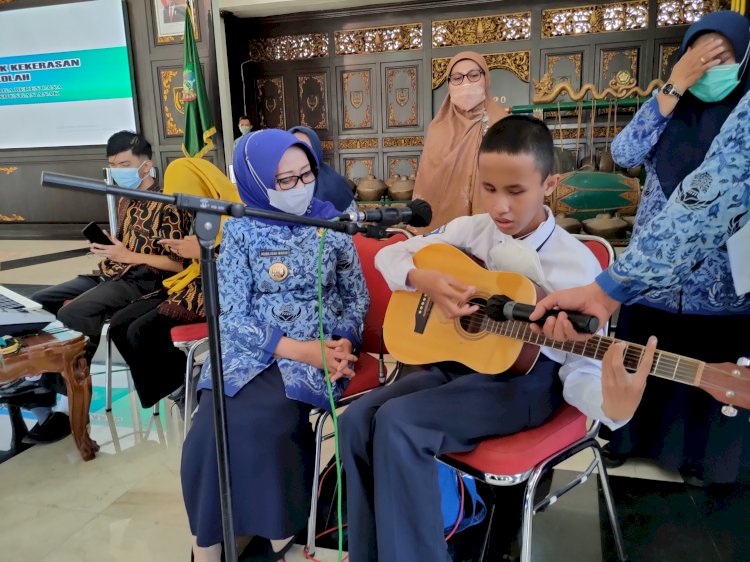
[340,116,654,562]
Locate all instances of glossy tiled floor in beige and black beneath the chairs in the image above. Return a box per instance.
[0,231,750,562]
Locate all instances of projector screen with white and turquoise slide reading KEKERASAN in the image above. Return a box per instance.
[0,0,136,149]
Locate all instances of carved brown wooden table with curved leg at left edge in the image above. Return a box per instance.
[0,327,99,461]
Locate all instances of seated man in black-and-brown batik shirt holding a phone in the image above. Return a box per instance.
[0,131,191,443]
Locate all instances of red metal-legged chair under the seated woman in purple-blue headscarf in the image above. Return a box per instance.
[306,229,411,556]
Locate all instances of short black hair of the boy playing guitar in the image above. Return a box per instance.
[479,115,555,180]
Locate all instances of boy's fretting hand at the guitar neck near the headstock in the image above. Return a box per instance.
[602,336,657,421]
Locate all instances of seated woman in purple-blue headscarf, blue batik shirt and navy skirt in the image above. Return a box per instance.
[181,129,369,562]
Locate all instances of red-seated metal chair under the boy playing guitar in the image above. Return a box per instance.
[438,235,625,562]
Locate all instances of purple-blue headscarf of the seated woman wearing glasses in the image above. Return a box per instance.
[233,129,339,226]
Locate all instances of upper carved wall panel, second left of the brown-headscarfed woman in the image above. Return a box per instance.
[338,65,377,133]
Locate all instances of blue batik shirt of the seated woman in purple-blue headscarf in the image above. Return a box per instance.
[198,218,370,408]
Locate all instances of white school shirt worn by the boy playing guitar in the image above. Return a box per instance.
[375,207,628,429]
